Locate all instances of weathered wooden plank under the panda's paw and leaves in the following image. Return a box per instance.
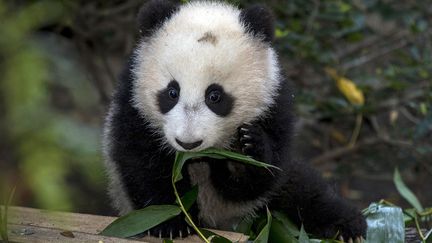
[8,207,248,243]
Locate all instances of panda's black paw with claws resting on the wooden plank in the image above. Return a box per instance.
[146,216,192,239]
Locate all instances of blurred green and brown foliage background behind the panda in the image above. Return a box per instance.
[0,0,432,215]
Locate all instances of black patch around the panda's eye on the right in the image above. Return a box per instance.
[205,84,234,116]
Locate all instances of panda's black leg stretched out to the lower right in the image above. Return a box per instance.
[269,161,367,239]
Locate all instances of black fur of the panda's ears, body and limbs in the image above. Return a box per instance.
[105,0,366,239]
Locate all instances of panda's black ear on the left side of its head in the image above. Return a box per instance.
[138,0,179,37]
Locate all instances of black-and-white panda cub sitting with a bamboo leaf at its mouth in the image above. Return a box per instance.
[104,0,366,239]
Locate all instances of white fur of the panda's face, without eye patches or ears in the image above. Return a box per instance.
[133,1,280,151]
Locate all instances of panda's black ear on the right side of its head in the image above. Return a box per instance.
[240,4,275,43]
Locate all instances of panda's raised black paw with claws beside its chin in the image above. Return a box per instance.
[238,123,266,161]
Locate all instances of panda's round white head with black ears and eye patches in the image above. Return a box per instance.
[133,0,280,151]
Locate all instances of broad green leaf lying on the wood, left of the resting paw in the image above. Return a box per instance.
[100,205,181,238]
